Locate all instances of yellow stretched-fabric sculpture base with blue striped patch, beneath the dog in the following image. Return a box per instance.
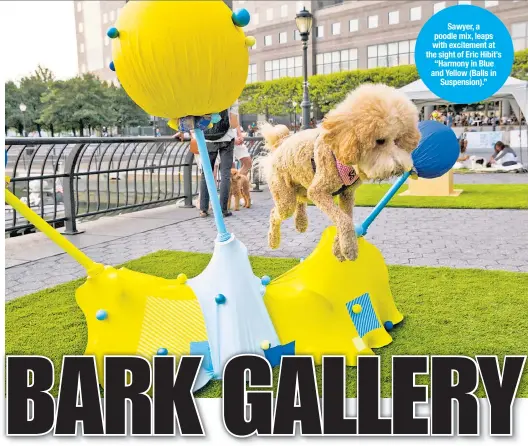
[264,227,403,366]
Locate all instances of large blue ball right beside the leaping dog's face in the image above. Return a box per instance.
[412,121,460,178]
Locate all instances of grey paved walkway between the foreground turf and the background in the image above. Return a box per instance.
[5,175,528,300]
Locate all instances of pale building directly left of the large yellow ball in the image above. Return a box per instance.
[74,0,126,83]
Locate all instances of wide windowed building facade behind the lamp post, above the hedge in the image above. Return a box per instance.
[241,0,528,82]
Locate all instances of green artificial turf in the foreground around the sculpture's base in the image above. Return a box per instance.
[5,251,528,397]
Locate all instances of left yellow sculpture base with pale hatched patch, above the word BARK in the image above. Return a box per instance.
[75,267,207,385]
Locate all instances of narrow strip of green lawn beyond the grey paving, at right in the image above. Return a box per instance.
[350,184,528,209]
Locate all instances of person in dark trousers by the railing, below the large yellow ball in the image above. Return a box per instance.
[200,103,239,217]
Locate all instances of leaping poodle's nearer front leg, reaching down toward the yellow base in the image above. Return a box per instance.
[308,179,358,261]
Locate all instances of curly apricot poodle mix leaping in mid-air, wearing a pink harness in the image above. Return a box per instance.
[260,84,420,261]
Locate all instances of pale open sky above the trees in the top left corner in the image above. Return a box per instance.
[0,0,77,81]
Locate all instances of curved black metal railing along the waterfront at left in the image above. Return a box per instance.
[5,137,263,236]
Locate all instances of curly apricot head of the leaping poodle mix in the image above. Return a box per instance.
[321,84,420,180]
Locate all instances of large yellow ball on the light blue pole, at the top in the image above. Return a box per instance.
[112,1,249,119]
